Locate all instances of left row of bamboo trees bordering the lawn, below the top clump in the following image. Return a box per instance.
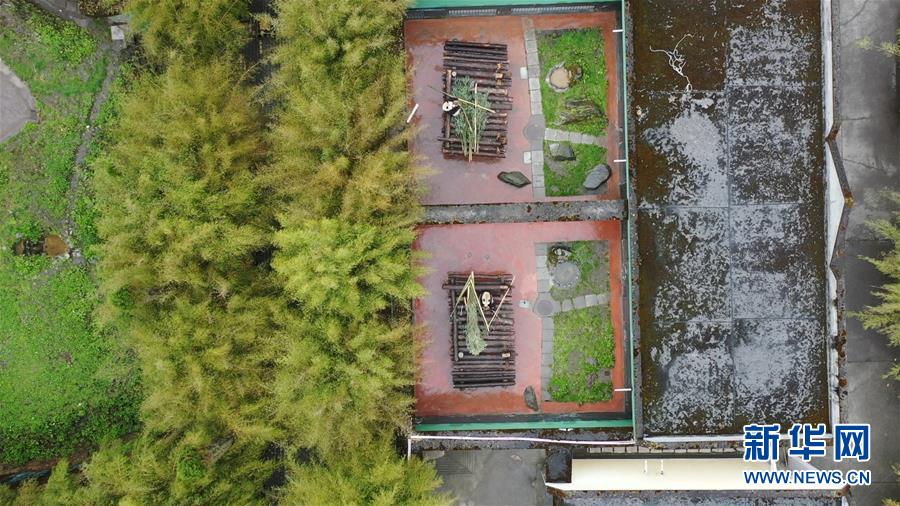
[88,57,278,503]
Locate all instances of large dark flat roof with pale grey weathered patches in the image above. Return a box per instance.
[631,0,827,434]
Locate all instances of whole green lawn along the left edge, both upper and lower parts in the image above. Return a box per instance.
[0,0,140,463]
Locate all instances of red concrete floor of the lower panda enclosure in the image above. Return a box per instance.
[414,221,626,416]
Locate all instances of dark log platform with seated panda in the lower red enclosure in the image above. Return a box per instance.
[444,273,516,389]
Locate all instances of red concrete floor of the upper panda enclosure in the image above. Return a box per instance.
[404,12,624,205]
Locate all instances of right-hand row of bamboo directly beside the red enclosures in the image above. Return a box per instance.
[267,0,445,504]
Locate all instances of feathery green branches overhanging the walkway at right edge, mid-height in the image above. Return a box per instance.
[854,193,900,380]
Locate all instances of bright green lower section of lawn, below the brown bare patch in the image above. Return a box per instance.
[0,250,140,464]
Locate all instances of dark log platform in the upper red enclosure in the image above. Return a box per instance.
[439,40,512,158]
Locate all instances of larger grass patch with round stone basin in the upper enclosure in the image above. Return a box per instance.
[538,28,609,135]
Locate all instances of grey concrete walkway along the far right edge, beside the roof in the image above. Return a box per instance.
[836,0,900,506]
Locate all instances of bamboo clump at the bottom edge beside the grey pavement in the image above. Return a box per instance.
[280,442,449,506]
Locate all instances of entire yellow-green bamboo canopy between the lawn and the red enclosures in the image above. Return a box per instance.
[4,0,446,504]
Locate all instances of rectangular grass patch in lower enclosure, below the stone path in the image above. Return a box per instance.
[548,306,616,404]
